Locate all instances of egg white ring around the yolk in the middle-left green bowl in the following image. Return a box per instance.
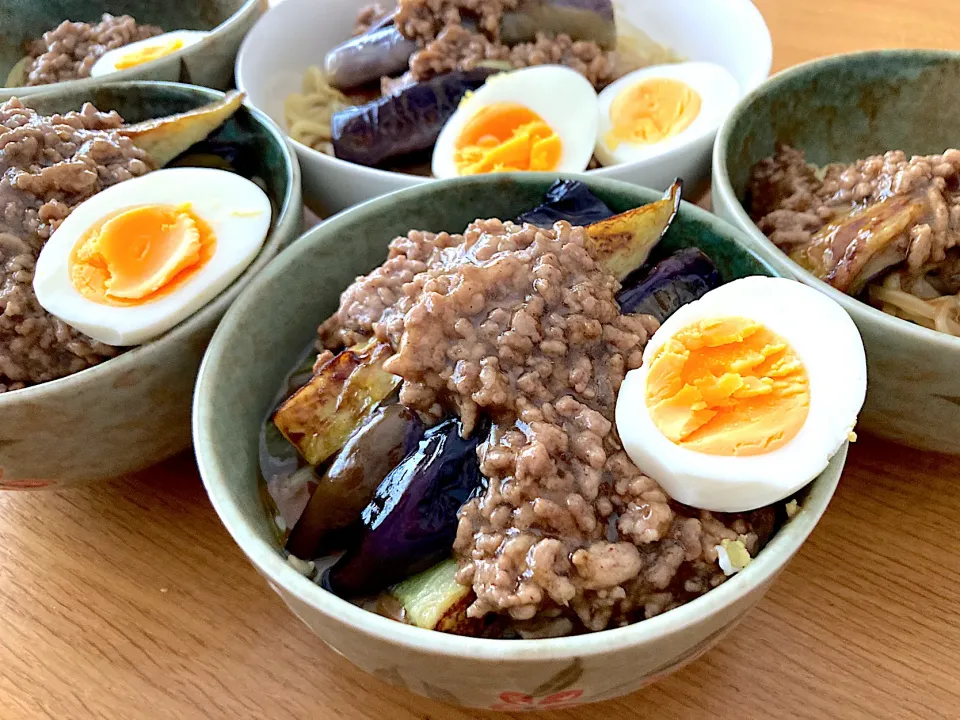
[33,168,271,346]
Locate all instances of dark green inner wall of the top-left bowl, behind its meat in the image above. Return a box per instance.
[0,0,246,85]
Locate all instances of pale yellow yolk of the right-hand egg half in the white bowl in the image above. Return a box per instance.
[605,78,701,150]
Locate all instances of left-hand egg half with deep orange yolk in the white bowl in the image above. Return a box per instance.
[433,65,598,178]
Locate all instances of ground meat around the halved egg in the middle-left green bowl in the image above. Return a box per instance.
[0,98,153,393]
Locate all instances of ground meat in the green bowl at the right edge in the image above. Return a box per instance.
[749,145,960,272]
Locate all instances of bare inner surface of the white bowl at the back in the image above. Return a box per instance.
[237,0,771,169]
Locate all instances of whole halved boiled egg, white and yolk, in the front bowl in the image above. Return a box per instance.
[616,277,867,512]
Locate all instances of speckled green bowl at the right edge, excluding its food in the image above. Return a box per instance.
[713,50,960,454]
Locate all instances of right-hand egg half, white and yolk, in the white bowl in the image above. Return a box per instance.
[595,62,740,165]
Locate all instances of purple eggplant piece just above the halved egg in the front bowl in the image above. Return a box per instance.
[617,248,722,322]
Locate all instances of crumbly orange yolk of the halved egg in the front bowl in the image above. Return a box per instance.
[646,317,810,456]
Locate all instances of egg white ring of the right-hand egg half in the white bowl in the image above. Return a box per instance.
[594,62,740,166]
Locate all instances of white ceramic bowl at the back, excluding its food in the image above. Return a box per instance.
[236,0,772,216]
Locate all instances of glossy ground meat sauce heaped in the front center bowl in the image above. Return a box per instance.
[320,220,774,634]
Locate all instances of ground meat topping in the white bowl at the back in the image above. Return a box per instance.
[386,0,624,91]
